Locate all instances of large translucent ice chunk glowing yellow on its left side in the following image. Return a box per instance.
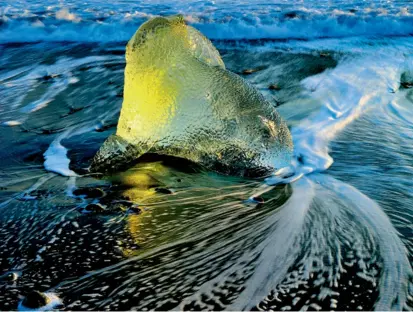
[91,15,293,177]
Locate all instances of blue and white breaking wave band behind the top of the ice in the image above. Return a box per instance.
[0,1,413,42]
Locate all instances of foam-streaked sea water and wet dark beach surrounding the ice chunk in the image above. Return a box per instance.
[0,0,413,311]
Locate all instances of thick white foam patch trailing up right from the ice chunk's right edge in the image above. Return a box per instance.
[266,48,405,185]
